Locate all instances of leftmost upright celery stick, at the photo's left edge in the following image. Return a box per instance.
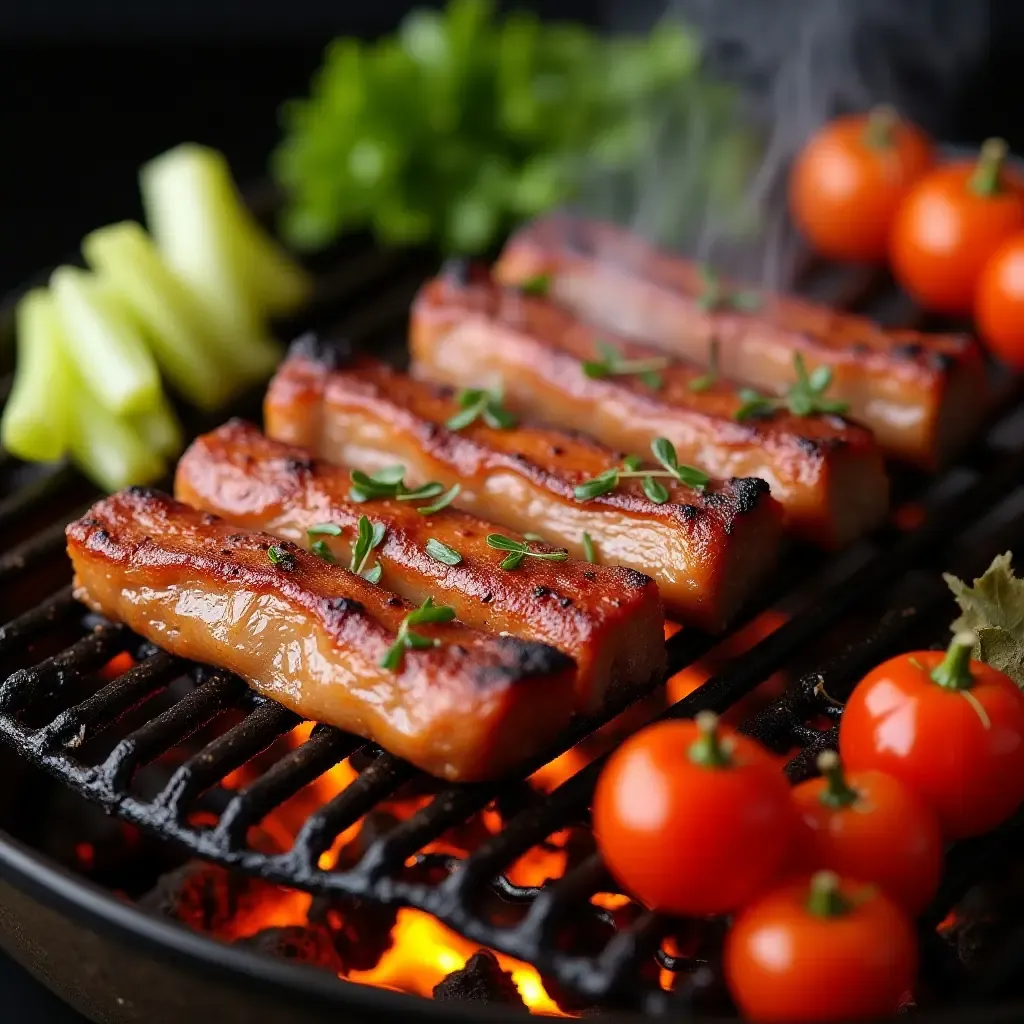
[0,288,71,462]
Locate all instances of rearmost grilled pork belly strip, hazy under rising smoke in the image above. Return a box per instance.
[495,216,987,469]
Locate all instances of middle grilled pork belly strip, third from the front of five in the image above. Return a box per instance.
[264,349,781,630]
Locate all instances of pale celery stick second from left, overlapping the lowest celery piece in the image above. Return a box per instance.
[50,266,160,414]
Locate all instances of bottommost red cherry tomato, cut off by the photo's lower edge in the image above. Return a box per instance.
[725,871,918,1021]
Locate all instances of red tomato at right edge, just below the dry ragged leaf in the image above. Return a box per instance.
[839,633,1024,839]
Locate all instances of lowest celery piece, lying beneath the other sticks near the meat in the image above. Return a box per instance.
[70,381,167,492]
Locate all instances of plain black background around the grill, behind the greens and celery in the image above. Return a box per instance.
[0,0,1024,1024]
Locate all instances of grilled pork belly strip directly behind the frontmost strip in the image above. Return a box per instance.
[174,420,665,711]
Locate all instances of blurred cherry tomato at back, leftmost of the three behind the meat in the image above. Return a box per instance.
[790,108,935,262]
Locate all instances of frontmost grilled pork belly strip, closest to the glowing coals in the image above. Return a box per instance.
[68,488,574,779]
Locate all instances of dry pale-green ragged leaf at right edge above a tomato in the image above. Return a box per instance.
[942,551,1024,689]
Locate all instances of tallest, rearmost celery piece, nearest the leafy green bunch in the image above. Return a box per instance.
[140,143,312,315]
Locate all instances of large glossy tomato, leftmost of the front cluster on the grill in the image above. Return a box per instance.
[593,713,796,914]
